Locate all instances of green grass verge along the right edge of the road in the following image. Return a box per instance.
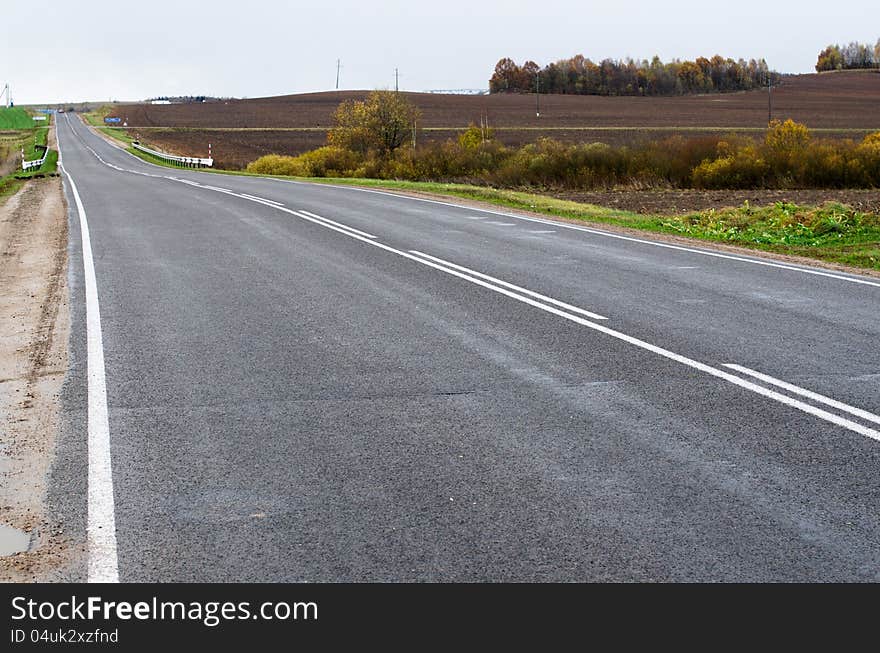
[94,128,880,270]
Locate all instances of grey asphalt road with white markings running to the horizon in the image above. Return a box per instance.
[50,116,880,581]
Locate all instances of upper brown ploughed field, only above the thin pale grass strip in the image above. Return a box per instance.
[119,71,880,129]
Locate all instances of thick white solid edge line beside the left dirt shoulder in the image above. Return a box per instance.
[56,116,119,583]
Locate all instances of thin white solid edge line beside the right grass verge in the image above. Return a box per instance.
[280,177,880,288]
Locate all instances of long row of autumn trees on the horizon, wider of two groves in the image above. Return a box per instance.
[489,54,777,96]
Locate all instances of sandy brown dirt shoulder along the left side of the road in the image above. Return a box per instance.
[0,171,77,582]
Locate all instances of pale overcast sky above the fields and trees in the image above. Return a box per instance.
[0,0,880,104]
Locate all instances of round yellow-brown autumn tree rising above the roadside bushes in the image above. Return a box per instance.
[327,91,421,155]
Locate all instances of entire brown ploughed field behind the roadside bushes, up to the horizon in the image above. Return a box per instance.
[115,71,880,169]
